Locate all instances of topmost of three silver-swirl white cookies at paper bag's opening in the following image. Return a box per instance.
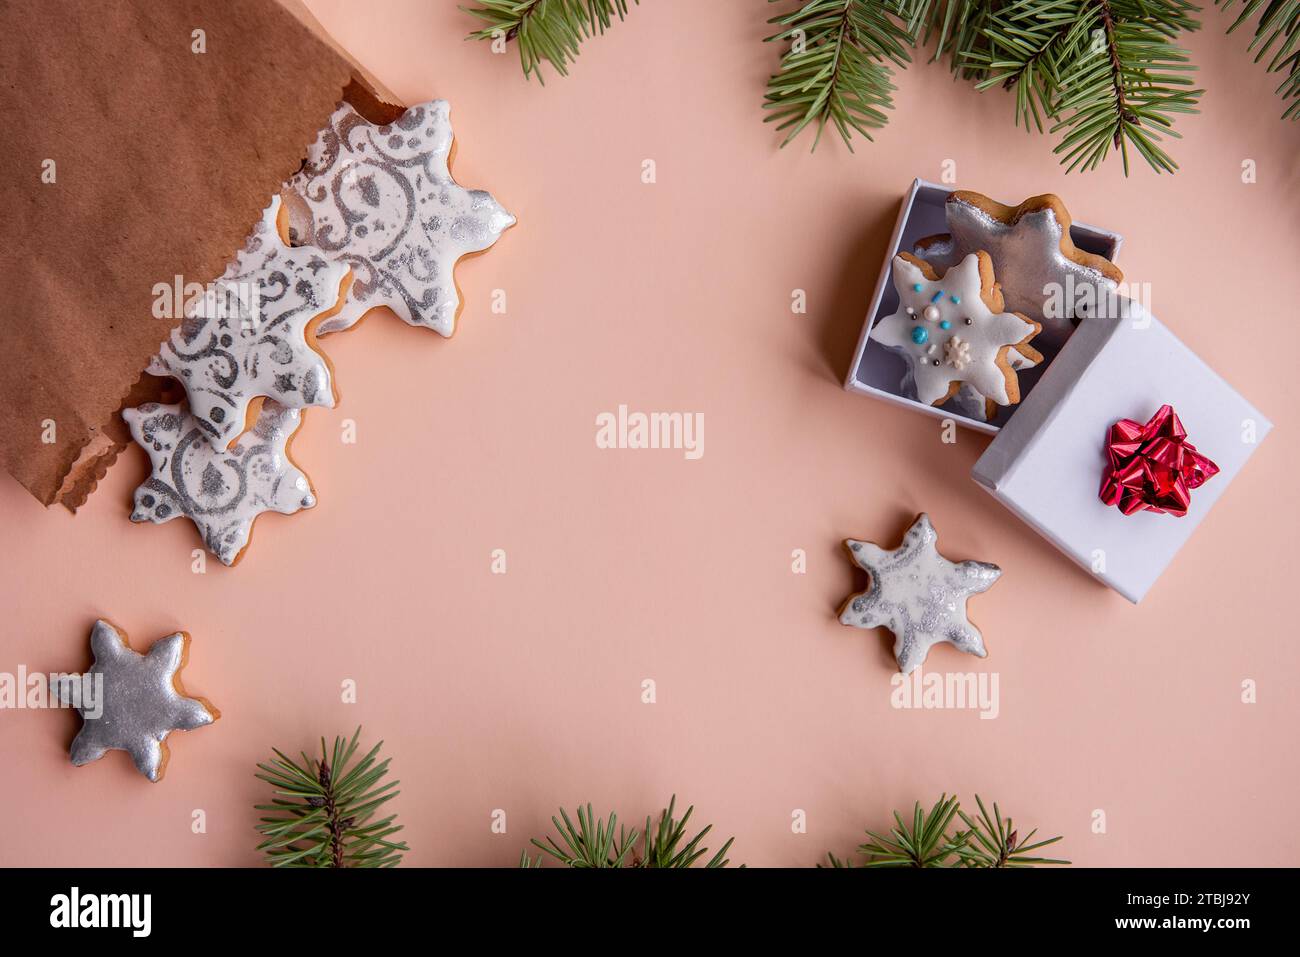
[286,100,515,335]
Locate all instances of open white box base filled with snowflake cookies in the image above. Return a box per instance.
[845,179,1123,432]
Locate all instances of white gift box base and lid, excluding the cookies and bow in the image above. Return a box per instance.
[845,179,1271,602]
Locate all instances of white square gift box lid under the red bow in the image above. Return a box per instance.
[971,300,1273,603]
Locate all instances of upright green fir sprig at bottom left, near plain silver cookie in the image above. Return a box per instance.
[255,728,410,867]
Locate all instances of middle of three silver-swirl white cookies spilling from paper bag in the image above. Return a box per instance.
[148,196,348,446]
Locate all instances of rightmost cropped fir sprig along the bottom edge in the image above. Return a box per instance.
[818,794,1070,867]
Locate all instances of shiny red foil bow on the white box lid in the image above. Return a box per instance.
[1101,406,1218,518]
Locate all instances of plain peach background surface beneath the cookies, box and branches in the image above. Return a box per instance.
[0,0,1300,865]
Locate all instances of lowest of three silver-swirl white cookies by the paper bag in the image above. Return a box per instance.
[122,399,316,564]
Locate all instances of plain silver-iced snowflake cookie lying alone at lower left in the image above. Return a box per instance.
[56,619,221,781]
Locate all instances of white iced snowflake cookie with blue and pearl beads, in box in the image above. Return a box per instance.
[871,252,1041,406]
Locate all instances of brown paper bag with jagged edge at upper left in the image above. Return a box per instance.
[0,0,402,510]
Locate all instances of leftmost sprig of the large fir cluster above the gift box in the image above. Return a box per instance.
[763,0,914,152]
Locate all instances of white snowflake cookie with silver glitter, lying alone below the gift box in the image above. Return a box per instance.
[840,512,1002,675]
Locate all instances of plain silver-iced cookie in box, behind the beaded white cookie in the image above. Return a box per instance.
[913,190,1125,350]
